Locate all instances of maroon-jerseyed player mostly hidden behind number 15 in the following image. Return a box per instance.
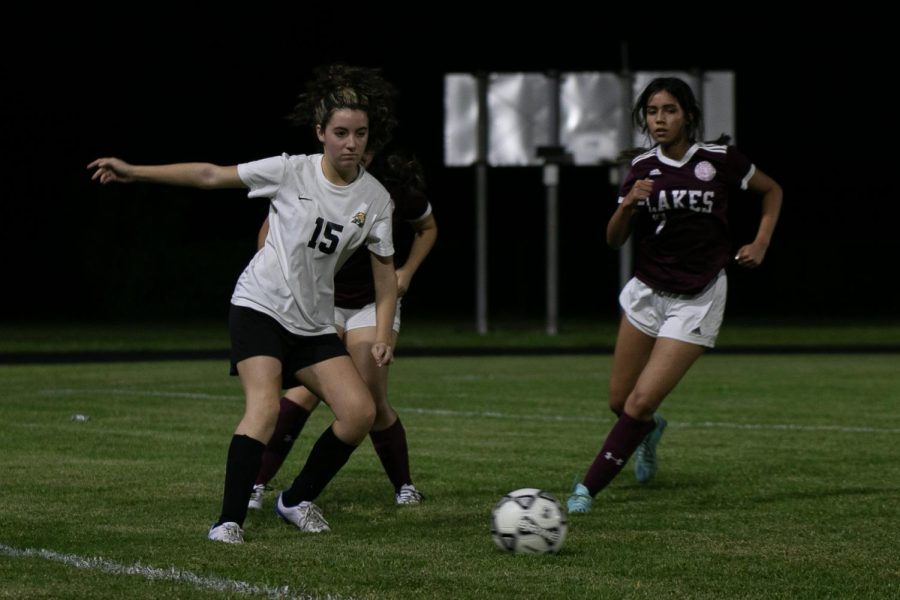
[248,154,437,509]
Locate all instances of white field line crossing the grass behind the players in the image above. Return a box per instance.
[40,389,900,434]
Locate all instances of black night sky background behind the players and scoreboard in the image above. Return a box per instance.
[0,14,900,324]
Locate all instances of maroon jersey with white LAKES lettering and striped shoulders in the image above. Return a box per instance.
[619,144,756,294]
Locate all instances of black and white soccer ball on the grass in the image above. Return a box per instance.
[491,488,569,554]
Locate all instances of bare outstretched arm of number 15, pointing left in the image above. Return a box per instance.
[87,157,246,189]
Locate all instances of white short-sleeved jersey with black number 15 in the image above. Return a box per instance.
[231,154,394,335]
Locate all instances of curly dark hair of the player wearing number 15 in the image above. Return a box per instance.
[288,64,397,152]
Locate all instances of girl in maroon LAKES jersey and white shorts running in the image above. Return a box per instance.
[567,78,782,513]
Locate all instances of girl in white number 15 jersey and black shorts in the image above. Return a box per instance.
[88,66,397,543]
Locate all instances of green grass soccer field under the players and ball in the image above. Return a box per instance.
[0,354,900,599]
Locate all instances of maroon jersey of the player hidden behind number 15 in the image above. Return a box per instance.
[334,181,431,308]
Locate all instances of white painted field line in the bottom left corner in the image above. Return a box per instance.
[0,544,350,600]
